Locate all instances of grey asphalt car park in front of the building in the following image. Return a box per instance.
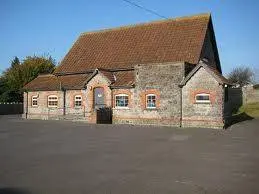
[0,116,259,194]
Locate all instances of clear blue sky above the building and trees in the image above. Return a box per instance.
[0,0,259,78]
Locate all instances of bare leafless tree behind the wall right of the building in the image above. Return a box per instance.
[228,66,254,87]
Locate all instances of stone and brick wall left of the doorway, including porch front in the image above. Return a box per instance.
[23,74,112,123]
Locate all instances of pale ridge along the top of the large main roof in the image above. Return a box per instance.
[80,12,211,36]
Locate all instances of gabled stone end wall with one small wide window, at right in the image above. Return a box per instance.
[182,68,224,128]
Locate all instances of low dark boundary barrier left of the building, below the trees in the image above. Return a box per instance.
[0,103,23,115]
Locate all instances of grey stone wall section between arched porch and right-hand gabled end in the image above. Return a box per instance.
[113,63,185,126]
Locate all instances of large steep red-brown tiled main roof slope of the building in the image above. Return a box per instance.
[55,14,210,73]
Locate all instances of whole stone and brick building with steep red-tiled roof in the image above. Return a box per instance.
[23,14,234,128]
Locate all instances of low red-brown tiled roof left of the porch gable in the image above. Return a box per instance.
[23,74,91,91]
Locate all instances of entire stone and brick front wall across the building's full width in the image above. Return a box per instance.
[24,63,224,127]
